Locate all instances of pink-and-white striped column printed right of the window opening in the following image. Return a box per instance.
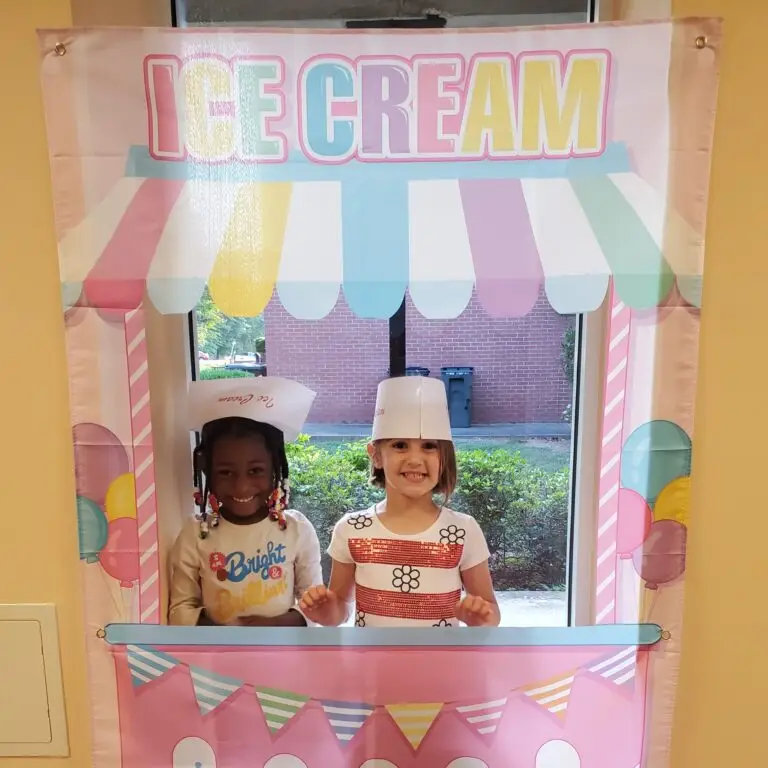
[595,281,631,624]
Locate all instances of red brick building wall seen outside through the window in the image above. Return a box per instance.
[264,295,573,424]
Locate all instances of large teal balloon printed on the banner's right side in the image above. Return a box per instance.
[621,421,691,504]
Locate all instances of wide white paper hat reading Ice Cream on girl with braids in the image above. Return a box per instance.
[188,376,315,443]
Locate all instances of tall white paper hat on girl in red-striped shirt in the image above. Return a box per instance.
[372,376,451,440]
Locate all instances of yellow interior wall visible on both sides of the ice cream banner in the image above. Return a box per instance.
[0,0,756,768]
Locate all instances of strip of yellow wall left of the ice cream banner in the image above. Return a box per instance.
[0,0,85,768]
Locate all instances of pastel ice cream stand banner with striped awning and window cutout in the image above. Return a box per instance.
[39,19,721,768]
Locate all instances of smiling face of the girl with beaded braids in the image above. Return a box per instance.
[209,435,275,518]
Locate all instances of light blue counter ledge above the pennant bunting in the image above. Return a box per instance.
[104,624,662,648]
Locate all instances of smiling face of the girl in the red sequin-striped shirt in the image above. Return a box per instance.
[368,438,441,499]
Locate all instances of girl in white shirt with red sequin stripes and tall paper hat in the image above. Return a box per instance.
[299,376,500,627]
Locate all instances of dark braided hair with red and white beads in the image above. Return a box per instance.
[192,416,290,539]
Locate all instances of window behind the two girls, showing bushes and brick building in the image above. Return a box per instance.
[178,0,601,626]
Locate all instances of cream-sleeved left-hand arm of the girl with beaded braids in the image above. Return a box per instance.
[168,520,206,627]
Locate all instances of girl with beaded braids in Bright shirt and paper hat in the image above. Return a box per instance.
[169,377,322,626]
